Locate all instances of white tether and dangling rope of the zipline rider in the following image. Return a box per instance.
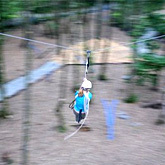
[64,50,91,140]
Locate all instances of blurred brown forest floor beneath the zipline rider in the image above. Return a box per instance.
[0,10,165,165]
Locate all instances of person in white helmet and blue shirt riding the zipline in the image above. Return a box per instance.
[73,78,92,123]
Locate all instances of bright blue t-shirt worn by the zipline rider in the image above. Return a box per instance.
[74,91,92,112]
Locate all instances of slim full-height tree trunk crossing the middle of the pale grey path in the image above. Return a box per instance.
[22,0,32,165]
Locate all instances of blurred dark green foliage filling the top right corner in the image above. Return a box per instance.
[112,0,165,38]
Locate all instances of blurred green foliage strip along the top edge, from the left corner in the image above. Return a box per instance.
[0,0,96,21]
